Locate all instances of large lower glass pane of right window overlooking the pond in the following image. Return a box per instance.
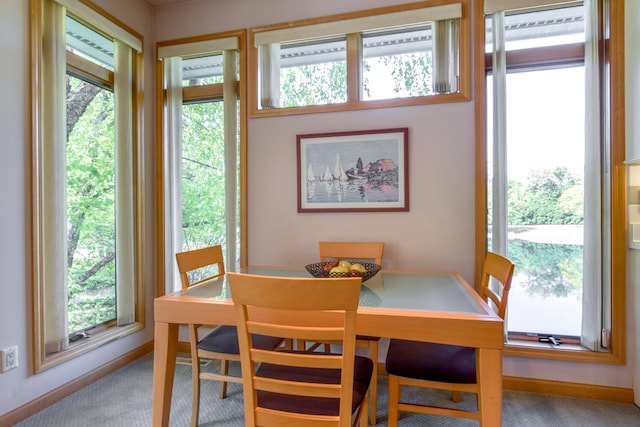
[487,66,584,337]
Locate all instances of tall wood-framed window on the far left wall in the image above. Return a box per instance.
[31,0,142,371]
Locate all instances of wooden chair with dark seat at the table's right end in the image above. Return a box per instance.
[386,252,514,427]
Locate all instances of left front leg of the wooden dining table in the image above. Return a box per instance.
[152,322,178,427]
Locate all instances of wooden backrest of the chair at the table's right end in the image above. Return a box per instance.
[480,252,515,319]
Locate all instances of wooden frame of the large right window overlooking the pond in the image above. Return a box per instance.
[473,0,627,365]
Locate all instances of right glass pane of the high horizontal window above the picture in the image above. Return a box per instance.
[362,26,433,100]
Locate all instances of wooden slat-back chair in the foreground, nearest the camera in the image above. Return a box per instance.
[227,273,373,427]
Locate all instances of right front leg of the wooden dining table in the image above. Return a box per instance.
[477,348,502,427]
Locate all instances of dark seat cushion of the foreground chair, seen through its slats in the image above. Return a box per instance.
[256,356,373,415]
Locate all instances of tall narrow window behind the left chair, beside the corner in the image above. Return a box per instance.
[158,31,245,293]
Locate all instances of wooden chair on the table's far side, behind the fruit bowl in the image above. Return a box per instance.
[319,242,384,425]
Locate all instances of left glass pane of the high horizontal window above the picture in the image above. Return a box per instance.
[280,37,347,107]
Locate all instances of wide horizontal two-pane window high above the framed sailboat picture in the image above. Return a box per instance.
[250,0,469,116]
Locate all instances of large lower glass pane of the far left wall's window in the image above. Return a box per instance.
[66,75,116,333]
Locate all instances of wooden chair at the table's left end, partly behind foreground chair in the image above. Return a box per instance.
[176,245,281,426]
